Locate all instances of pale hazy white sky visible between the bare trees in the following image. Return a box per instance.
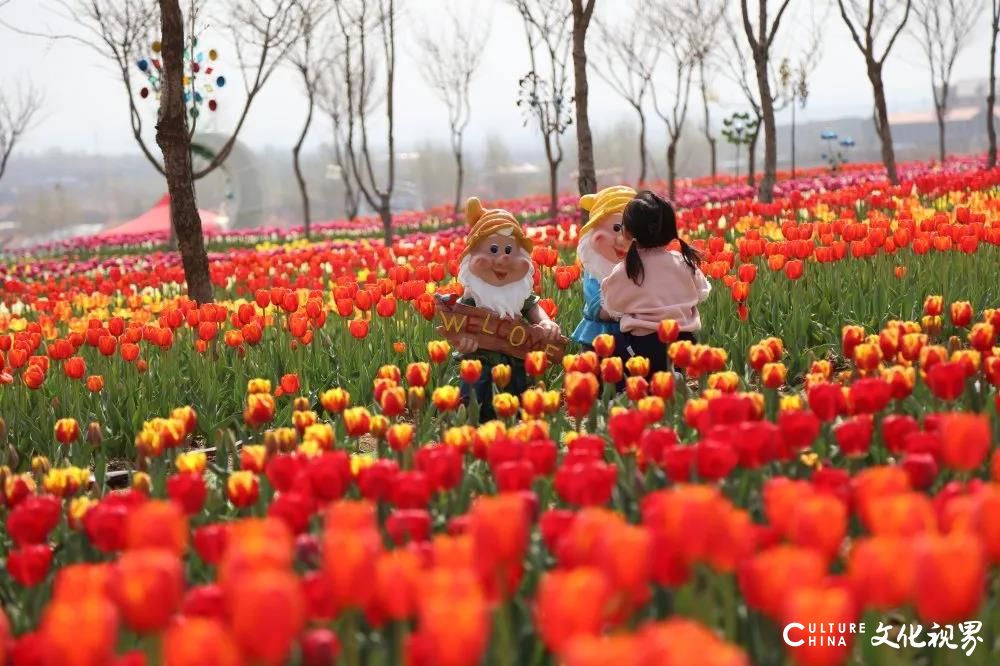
[0,0,989,154]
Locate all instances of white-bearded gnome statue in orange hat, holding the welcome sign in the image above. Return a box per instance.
[455,197,560,421]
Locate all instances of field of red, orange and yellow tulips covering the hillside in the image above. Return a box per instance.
[0,158,1000,666]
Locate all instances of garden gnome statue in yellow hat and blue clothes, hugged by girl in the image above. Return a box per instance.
[573,185,635,350]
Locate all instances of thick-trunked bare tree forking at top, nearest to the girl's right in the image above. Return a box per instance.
[740,0,791,202]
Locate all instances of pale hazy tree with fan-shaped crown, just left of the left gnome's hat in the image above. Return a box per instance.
[417,2,489,216]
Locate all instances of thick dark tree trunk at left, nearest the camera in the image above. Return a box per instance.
[156,0,212,303]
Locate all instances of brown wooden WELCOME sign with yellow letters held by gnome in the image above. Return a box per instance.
[437,295,569,363]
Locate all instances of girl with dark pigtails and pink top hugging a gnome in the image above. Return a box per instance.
[601,190,712,372]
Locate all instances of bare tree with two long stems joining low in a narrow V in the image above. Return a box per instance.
[334,0,396,247]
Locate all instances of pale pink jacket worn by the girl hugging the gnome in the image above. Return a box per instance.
[601,248,712,335]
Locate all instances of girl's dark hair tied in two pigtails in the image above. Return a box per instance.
[622,190,701,284]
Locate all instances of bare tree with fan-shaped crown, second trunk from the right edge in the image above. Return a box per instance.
[912,0,983,163]
